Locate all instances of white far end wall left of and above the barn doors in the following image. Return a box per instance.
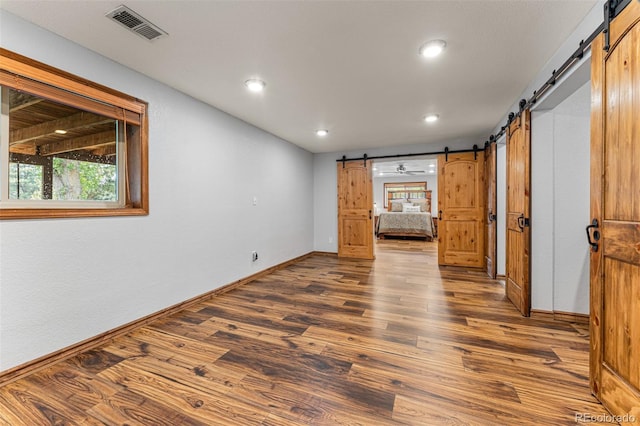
[313,140,481,253]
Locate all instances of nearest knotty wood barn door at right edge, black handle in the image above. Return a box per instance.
[587,1,640,424]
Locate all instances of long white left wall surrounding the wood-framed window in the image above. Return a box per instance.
[0,10,316,370]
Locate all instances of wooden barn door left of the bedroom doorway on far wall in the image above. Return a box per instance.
[338,160,373,259]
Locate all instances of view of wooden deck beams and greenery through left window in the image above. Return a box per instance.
[3,89,124,203]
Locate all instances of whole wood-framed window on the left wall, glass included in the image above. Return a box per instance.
[0,50,148,218]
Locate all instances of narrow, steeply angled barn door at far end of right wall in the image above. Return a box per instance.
[484,143,498,279]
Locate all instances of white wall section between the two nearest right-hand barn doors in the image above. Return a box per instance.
[531,82,591,314]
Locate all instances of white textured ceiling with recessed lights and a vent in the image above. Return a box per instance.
[0,0,596,152]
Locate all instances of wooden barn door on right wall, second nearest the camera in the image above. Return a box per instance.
[505,109,531,317]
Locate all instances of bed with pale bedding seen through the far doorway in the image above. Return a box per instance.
[376,199,434,241]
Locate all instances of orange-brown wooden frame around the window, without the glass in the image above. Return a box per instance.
[0,48,149,219]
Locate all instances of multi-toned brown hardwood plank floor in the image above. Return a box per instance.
[0,240,606,426]
